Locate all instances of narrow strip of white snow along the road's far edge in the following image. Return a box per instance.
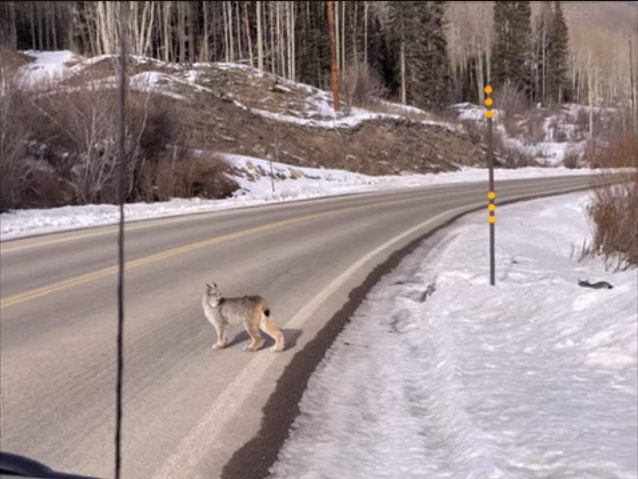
[0,155,612,241]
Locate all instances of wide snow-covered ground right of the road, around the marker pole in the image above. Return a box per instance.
[271,193,638,479]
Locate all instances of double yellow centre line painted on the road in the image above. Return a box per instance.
[0,211,336,309]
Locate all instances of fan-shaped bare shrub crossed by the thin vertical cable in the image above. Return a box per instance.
[33,87,181,204]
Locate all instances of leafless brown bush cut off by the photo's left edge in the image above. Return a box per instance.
[0,68,32,212]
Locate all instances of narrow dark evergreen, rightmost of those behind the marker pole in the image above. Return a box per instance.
[548,1,569,103]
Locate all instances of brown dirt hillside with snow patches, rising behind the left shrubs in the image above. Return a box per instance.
[13,48,483,175]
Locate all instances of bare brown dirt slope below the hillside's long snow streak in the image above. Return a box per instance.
[182,98,484,175]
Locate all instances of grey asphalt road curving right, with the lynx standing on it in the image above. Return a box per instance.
[0,177,608,479]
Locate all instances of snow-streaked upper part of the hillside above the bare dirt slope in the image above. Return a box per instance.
[16,51,458,129]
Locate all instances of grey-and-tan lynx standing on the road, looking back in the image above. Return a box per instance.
[202,282,285,352]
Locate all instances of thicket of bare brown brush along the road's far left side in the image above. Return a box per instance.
[0,71,238,212]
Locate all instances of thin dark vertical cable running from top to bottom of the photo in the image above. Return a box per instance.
[115,2,128,479]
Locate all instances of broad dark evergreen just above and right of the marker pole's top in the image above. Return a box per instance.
[491,1,533,96]
